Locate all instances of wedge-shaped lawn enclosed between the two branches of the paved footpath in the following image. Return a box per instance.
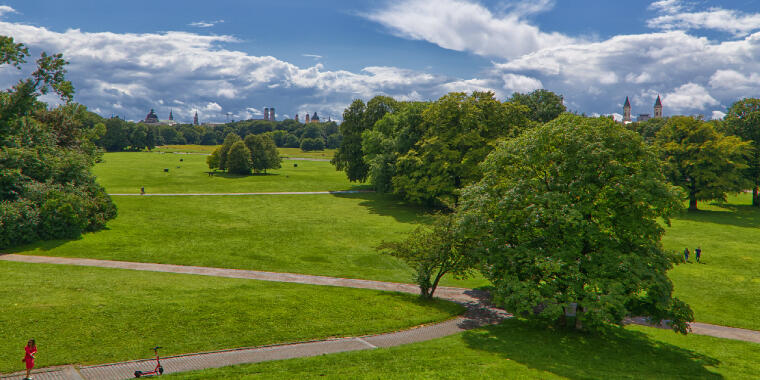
[0,262,462,373]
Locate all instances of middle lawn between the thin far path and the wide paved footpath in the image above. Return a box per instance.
[7,193,485,286]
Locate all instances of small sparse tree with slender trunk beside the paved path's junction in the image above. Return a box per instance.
[377,216,471,298]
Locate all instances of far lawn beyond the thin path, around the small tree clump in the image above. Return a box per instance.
[93,152,368,194]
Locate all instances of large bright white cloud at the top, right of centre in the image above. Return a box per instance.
[364,0,574,58]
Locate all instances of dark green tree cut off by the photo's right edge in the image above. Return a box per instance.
[724,98,760,207]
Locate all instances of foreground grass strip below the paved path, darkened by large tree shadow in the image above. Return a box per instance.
[169,320,760,380]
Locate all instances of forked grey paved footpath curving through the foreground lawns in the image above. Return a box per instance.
[0,254,760,380]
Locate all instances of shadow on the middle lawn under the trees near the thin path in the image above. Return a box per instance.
[333,193,432,223]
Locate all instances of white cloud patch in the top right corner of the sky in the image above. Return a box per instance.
[647,0,760,36]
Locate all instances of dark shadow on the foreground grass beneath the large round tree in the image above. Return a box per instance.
[463,318,723,379]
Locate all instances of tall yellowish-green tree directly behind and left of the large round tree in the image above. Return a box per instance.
[393,92,529,206]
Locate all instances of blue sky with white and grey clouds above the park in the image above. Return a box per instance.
[0,0,760,121]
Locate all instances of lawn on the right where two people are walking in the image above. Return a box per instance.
[663,194,760,330]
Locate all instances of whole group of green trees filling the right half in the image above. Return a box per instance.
[333,90,760,333]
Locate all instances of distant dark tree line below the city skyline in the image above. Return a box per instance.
[90,114,342,152]
